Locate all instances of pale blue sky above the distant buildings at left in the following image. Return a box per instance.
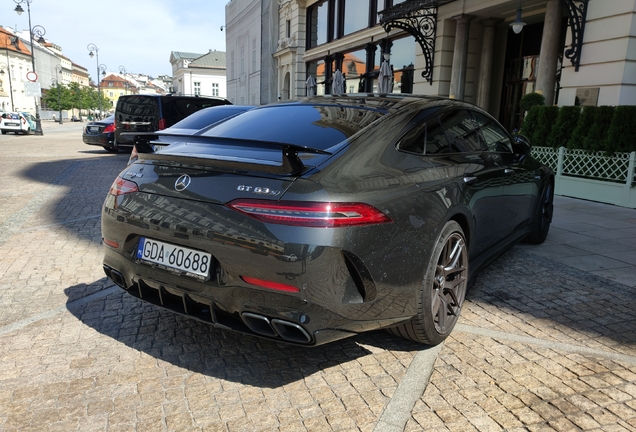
[0,0,229,79]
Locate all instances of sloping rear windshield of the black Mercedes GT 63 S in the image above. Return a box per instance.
[203,105,384,150]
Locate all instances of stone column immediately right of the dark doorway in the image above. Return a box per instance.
[535,0,562,105]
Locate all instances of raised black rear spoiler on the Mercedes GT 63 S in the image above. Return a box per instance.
[131,133,333,175]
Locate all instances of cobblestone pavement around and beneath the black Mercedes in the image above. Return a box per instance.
[0,122,636,432]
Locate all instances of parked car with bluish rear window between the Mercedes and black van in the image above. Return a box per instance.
[122,105,254,165]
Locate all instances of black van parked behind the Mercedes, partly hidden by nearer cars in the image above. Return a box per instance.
[114,94,232,148]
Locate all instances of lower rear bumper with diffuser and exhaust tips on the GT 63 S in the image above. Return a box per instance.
[103,252,410,346]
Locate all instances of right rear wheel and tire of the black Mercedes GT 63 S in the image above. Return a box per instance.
[389,221,468,345]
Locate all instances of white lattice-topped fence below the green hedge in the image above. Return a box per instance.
[532,147,636,208]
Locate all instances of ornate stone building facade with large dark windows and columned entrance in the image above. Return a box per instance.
[226,0,636,129]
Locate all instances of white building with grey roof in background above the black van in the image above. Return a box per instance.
[170,50,227,97]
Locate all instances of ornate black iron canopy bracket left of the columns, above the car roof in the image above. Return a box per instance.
[378,0,455,84]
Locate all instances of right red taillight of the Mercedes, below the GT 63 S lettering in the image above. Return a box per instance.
[227,199,392,228]
